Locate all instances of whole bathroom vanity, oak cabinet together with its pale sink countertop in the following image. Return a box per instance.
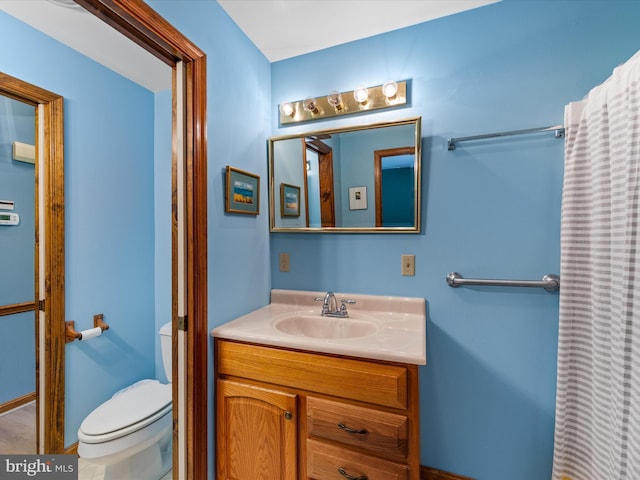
[212,290,426,480]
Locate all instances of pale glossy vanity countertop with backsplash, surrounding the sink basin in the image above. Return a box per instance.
[211,290,427,365]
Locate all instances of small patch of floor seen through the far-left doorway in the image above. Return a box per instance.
[0,402,36,455]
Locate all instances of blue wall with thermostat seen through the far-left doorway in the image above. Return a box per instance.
[0,97,36,404]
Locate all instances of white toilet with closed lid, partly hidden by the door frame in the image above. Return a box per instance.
[78,323,173,480]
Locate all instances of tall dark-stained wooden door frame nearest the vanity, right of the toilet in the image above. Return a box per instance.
[67,0,209,480]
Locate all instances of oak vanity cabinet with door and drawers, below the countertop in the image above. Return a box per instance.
[215,338,420,480]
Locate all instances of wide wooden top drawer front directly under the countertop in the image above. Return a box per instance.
[216,340,409,409]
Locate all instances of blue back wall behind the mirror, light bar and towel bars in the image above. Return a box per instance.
[271,0,640,480]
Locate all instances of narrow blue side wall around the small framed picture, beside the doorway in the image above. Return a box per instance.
[147,0,271,478]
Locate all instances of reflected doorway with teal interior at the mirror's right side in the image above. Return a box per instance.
[374,146,415,227]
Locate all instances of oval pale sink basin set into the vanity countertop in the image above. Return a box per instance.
[273,314,378,338]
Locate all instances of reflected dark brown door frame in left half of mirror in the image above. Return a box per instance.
[305,135,336,227]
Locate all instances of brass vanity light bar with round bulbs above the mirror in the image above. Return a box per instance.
[279,80,408,125]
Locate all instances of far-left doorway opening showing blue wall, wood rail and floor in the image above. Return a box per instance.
[0,96,36,454]
